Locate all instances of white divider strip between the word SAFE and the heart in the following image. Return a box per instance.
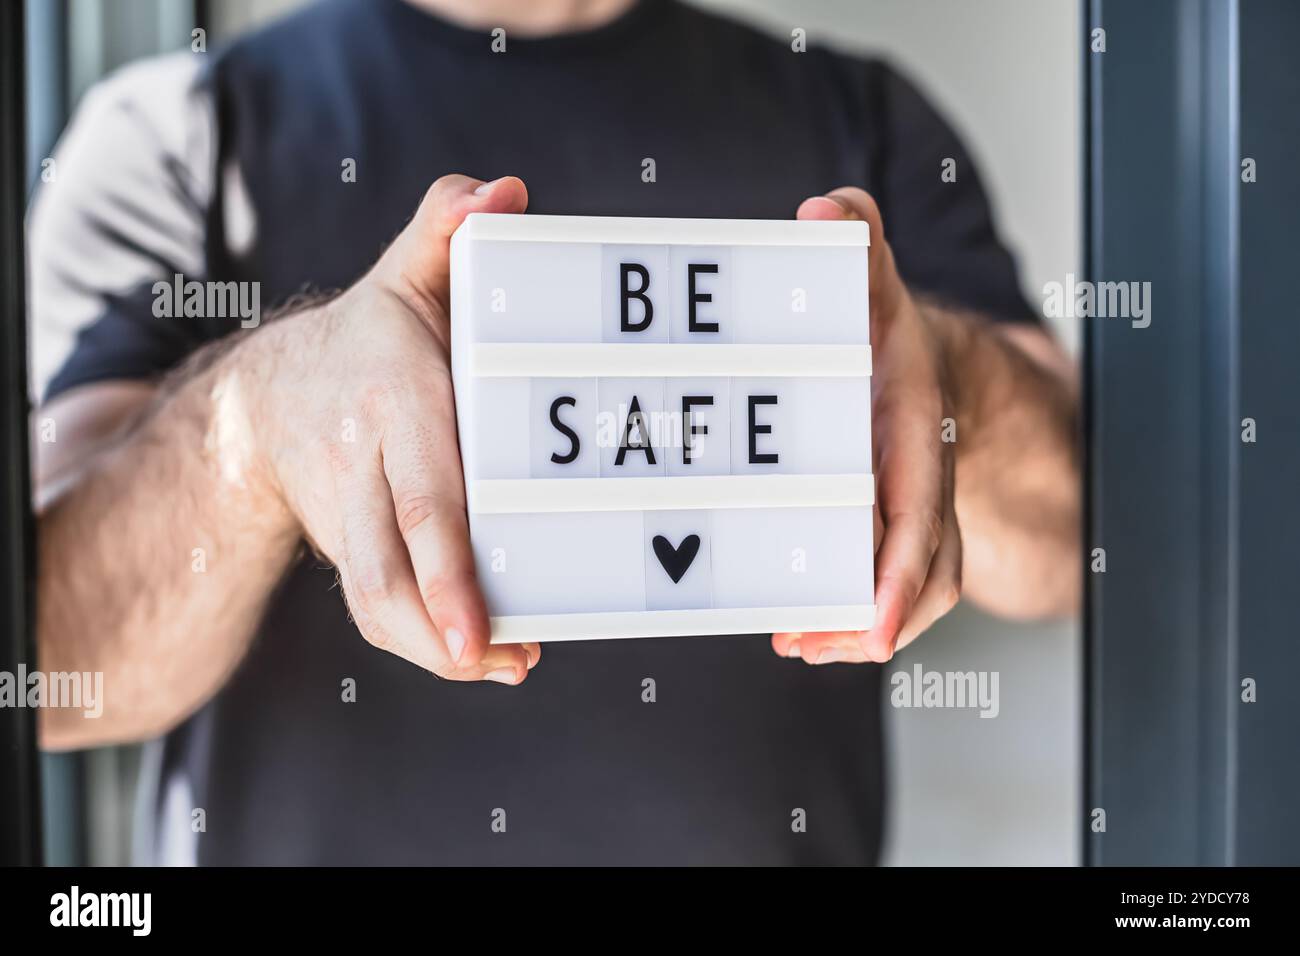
[469,473,875,515]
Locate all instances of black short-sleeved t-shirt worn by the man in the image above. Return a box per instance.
[33,0,1032,864]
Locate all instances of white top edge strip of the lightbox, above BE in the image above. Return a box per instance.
[456,212,871,252]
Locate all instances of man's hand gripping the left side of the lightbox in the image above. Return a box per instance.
[226,176,541,684]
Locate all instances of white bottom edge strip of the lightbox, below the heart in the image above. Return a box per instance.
[491,604,876,644]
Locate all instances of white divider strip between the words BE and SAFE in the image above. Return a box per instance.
[469,342,871,378]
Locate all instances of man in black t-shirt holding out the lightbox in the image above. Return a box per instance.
[33,0,1079,864]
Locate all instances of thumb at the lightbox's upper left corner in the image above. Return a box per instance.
[376,176,528,312]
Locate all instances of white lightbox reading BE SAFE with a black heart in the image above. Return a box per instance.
[451,213,875,643]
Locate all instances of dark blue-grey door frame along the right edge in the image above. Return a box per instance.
[1083,0,1300,865]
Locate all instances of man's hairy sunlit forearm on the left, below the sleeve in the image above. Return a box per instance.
[36,333,298,748]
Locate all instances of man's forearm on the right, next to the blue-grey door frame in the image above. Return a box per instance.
[924,306,1082,618]
